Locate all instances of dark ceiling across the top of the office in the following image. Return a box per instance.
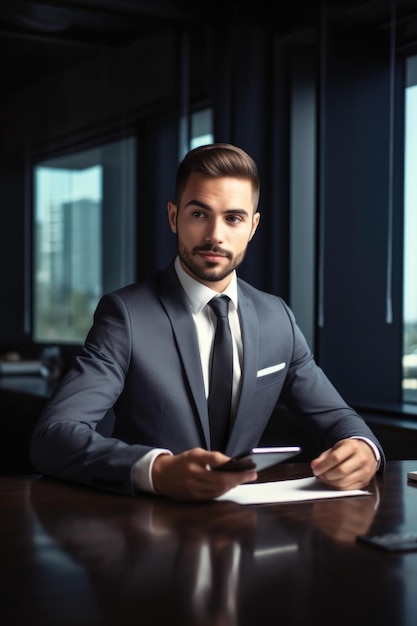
[0,0,417,92]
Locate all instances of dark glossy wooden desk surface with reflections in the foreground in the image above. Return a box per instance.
[0,460,417,626]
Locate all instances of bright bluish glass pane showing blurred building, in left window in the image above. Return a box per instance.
[33,165,103,342]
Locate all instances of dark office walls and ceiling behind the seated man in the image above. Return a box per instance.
[0,0,417,472]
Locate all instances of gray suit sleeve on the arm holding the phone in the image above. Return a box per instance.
[30,295,150,495]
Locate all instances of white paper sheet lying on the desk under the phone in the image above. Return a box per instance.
[215,476,371,504]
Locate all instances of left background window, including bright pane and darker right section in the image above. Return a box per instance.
[33,138,136,344]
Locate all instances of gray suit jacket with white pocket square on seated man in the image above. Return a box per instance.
[31,264,385,494]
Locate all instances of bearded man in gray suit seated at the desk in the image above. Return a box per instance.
[31,144,385,500]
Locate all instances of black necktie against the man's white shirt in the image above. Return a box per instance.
[208,296,233,452]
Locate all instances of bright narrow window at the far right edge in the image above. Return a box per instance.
[403,56,417,403]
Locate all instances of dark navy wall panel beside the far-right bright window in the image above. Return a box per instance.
[318,39,401,404]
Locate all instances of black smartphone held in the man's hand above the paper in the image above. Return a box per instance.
[211,446,301,472]
